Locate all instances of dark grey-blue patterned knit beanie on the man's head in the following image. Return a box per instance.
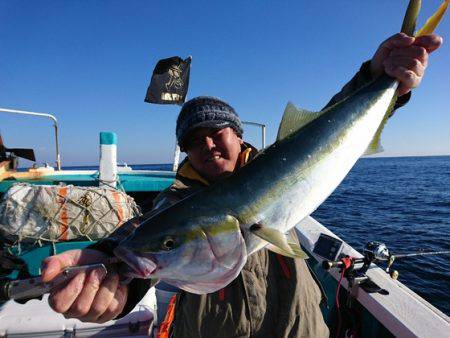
[176,96,244,150]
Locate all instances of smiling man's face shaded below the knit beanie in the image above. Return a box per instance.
[186,127,243,182]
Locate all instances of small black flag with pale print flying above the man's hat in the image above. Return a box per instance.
[145,56,192,104]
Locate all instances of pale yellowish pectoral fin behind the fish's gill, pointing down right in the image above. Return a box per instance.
[250,223,308,259]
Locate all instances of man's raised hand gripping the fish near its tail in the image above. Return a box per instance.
[370,33,442,96]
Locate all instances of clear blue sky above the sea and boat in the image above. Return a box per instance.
[0,0,450,165]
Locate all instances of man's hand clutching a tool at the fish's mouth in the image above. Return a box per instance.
[42,249,128,323]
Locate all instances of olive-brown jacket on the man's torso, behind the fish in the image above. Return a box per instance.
[151,145,328,338]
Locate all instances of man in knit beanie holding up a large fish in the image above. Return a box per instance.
[43,34,442,337]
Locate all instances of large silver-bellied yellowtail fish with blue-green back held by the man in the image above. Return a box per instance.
[114,0,448,294]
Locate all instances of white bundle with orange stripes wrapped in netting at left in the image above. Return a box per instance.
[0,183,140,243]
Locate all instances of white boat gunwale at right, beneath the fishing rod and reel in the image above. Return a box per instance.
[296,216,450,337]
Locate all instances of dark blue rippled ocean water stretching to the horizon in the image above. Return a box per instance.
[64,156,450,315]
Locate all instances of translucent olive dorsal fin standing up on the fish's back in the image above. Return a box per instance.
[277,102,322,141]
